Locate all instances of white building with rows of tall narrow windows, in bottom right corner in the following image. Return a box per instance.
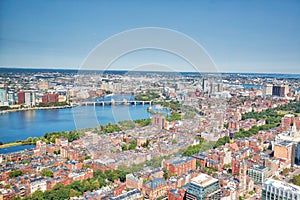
[262,179,300,200]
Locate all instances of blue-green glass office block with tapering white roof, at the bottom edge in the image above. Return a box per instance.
[186,173,221,200]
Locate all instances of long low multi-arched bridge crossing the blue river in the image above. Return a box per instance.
[74,100,152,106]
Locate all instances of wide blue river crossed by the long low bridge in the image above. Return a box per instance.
[0,96,165,154]
